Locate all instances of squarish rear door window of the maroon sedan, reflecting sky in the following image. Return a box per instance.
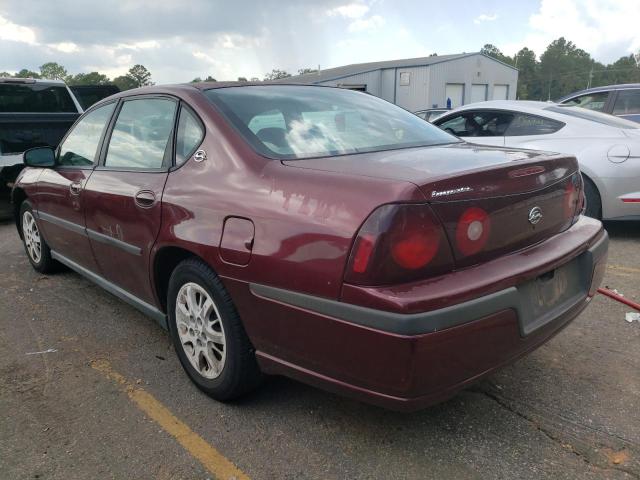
[104,98,177,169]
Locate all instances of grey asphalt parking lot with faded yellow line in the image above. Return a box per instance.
[0,219,640,480]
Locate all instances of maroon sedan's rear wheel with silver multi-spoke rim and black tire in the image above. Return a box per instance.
[167,258,261,401]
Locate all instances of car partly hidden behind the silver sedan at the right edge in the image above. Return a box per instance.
[558,83,640,123]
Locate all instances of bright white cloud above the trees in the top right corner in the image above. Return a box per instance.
[501,0,640,63]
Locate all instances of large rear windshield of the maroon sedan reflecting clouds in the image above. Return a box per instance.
[204,85,459,159]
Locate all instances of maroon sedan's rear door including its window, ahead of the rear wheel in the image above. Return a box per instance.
[85,95,178,302]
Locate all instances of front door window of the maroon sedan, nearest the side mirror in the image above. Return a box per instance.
[57,102,116,167]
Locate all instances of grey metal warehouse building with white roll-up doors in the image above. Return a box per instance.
[283,52,518,112]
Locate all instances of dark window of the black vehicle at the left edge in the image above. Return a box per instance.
[0,83,78,113]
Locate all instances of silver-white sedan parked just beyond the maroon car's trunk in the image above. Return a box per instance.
[433,100,640,220]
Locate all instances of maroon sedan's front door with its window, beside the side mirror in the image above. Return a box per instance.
[34,103,115,272]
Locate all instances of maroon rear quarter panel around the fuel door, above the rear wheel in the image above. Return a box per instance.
[155,93,425,299]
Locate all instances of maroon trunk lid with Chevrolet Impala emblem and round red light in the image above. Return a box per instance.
[284,143,581,268]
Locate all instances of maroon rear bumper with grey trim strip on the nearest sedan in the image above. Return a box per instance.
[232,219,608,410]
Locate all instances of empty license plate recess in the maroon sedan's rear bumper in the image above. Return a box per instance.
[517,255,591,336]
